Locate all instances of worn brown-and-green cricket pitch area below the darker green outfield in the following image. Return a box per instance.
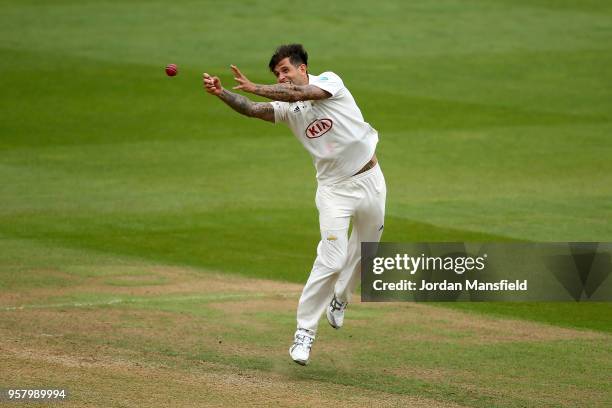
[0,247,612,407]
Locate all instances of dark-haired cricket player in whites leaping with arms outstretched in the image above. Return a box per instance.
[203,44,387,365]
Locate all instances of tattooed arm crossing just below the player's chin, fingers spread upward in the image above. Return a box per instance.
[231,65,331,102]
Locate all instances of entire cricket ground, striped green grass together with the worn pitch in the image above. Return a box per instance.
[0,0,612,407]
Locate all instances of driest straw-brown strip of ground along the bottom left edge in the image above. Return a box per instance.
[0,344,460,408]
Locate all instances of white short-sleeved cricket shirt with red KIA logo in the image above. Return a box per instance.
[271,72,378,185]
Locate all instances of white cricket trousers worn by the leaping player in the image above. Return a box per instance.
[297,164,387,333]
